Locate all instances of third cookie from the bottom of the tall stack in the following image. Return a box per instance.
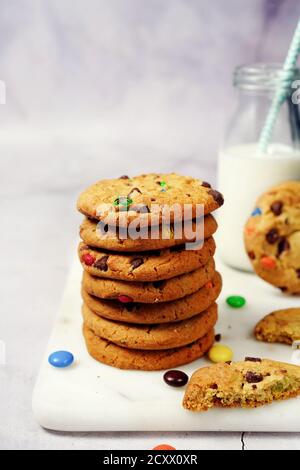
[81,272,222,324]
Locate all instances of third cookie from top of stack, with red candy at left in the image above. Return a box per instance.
[78,237,216,282]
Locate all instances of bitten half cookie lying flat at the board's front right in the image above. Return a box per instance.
[183,358,300,411]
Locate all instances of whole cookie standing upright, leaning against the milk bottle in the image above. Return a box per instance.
[244,181,300,294]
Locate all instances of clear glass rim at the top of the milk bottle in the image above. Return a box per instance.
[233,62,300,92]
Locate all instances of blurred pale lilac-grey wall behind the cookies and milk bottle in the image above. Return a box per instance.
[0,0,300,176]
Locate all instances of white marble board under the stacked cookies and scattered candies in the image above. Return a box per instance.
[33,262,300,432]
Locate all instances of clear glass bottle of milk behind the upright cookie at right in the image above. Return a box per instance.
[218,64,300,270]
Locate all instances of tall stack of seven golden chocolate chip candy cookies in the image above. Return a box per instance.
[78,174,223,370]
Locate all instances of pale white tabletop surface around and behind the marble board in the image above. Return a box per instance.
[0,136,300,450]
